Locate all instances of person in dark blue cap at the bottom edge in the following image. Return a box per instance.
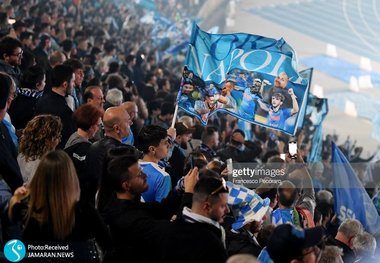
[259,224,323,263]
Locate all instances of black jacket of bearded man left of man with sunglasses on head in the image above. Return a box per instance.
[102,193,191,263]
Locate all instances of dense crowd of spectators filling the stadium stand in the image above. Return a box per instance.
[0,0,380,263]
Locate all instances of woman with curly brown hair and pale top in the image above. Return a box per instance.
[17,115,62,183]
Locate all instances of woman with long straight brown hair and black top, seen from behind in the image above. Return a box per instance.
[8,150,111,262]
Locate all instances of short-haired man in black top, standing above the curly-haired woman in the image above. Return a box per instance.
[36,65,76,149]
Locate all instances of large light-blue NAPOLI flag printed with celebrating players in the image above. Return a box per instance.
[178,23,308,134]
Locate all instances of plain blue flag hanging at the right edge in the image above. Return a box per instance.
[332,143,380,234]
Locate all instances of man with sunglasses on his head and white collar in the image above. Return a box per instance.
[157,177,229,263]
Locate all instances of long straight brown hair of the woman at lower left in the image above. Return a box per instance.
[26,150,80,240]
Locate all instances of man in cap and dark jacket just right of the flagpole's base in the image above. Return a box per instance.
[167,122,195,185]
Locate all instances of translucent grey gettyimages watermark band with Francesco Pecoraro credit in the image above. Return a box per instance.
[228,161,372,191]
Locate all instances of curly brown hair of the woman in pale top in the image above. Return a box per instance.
[19,114,62,161]
